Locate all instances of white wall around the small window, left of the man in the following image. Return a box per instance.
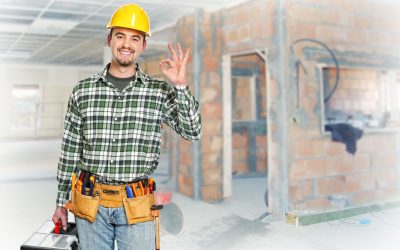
[0,64,103,139]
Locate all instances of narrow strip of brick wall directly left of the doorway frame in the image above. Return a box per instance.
[200,12,223,201]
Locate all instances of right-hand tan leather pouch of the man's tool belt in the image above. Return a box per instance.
[123,194,154,224]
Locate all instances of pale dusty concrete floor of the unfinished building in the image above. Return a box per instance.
[0,140,400,250]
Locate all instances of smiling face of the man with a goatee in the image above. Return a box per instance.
[108,28,146,67]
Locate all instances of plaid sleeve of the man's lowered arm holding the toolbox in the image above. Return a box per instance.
[57,92,82,206]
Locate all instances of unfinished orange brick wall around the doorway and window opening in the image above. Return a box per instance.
[139,0,400,217]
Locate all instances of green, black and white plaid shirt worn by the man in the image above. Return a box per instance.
[57,65,201,206]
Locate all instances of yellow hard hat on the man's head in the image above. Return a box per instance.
[107,4,151,36]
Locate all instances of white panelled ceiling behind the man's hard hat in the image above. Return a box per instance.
[0,0,245,65]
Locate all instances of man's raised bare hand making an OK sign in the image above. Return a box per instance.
[160,43,190,86]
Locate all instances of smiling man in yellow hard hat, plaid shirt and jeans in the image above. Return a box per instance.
[52,4,201,250]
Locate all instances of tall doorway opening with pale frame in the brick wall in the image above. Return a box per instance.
[223,50,268,219]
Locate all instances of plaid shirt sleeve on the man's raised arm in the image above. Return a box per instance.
[163,86,201,141]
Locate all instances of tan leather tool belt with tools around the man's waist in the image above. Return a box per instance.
[65,173,162,224]
